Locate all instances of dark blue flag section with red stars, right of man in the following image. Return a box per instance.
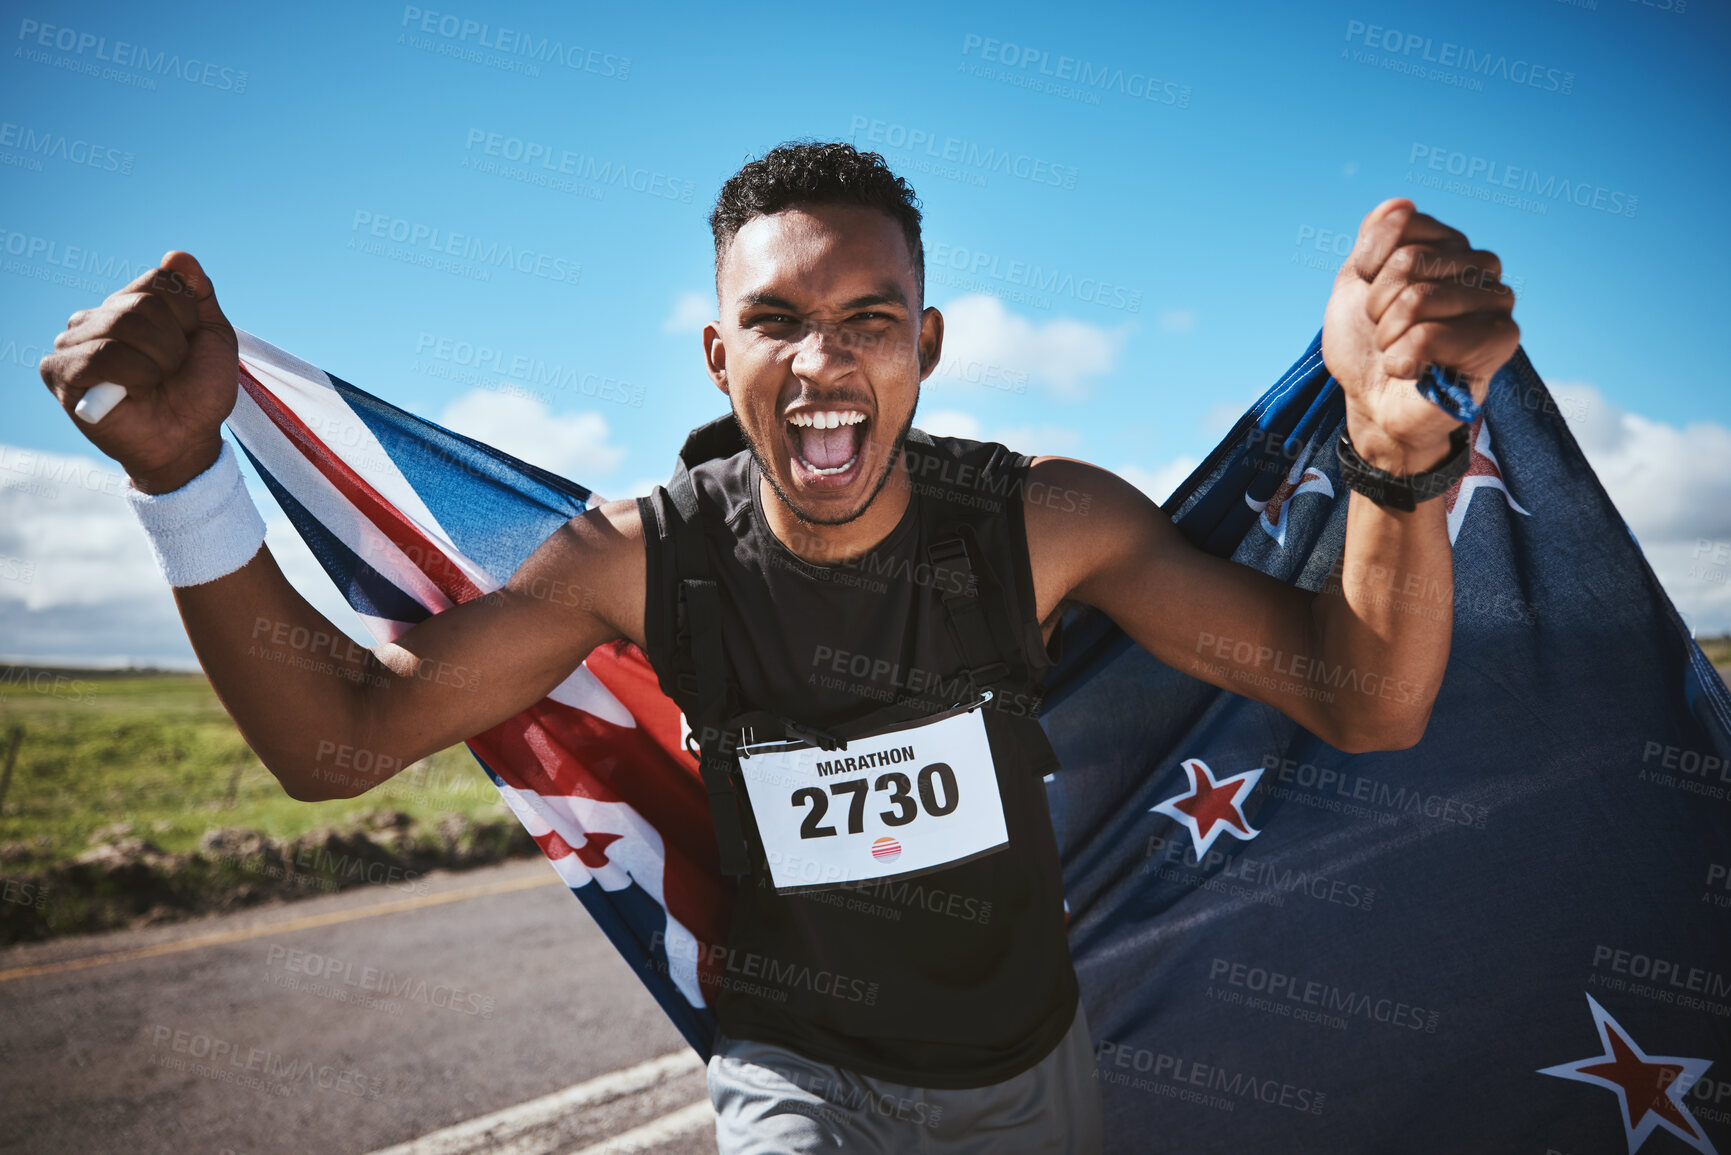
[1042,341,1731,1155]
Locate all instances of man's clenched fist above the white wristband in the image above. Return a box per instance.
[38,251,239,494]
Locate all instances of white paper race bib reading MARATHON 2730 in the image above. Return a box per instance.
[739,691,1009,894]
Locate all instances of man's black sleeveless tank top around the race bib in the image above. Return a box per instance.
[639,429,1078,1087]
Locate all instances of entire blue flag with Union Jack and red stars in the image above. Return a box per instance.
[230,334,1731,1155]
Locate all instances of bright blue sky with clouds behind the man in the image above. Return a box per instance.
[0,0,1731,660]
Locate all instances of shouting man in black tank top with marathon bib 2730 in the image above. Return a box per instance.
[42,144,1520,1152]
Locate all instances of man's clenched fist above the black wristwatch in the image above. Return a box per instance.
[1322,197,1520,473]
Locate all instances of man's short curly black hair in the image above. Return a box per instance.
[710,140,926,298]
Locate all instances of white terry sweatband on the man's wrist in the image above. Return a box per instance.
[125,442,265,585]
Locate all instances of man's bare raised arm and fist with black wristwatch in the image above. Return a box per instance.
[1025,199,1520,752]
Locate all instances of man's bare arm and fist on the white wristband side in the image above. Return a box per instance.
[40,253,644,800]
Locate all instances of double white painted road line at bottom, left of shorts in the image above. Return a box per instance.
[372,1048,710,1155]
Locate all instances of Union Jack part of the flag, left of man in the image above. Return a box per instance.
[228,332,732,1055]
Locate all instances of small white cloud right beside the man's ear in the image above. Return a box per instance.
[938,293,1130,398]
